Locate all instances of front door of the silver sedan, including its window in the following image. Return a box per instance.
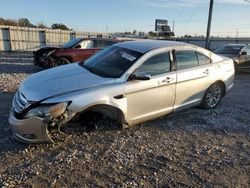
[125,51,176,124]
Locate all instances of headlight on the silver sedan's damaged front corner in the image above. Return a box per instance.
[24,102,68,119]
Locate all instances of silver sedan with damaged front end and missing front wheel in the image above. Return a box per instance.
[9,40,234,143]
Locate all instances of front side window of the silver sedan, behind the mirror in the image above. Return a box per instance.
[136,52,170,76]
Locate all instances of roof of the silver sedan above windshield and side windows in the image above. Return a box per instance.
[115,40,188,53]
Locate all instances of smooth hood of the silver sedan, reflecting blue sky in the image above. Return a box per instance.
[19,63,115,101]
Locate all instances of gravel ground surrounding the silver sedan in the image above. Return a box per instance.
[0,57,250,187]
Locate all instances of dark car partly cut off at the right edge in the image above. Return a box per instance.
[214,44,250,71]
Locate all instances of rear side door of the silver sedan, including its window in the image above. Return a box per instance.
[174,50,214,110]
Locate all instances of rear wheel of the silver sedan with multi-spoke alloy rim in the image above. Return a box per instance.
[201,83,223,109]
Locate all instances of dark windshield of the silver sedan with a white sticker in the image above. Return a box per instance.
[81,46,142,78]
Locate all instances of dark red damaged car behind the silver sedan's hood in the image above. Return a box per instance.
[34,38,121,68]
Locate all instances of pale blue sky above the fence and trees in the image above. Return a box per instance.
[0,0,250,37]
